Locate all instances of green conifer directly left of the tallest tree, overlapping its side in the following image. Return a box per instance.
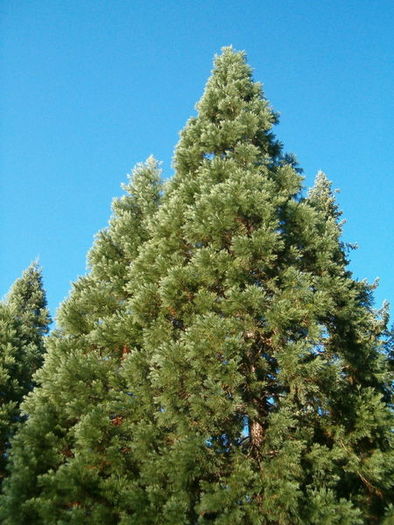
[1,158,161,524]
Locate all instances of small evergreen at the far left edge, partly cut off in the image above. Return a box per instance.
[0,263,50,484]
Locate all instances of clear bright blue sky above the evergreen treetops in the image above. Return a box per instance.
[0,0,394,317]
